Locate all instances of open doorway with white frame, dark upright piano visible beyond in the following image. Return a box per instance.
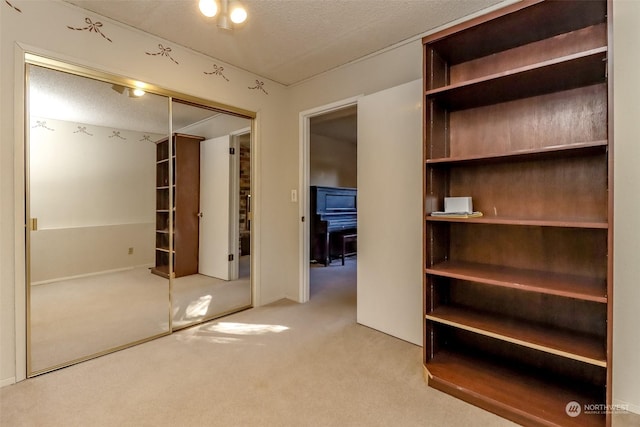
[299,98,357,302]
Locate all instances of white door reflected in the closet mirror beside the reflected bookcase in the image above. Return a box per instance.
[198,135,237,280]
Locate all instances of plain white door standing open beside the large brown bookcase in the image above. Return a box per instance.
[357,80,423,345]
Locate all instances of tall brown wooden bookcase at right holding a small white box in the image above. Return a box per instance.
[423,0,613,426]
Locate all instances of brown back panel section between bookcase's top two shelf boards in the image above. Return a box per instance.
[449,84,608,157]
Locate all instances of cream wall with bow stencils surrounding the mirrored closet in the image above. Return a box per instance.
[0,0,290,385]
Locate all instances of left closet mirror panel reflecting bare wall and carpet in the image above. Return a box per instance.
[27,65,169,374]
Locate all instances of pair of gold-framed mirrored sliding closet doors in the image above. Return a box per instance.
[25,56,252,376]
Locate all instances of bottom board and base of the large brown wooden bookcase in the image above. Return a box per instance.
[425,351,605,427]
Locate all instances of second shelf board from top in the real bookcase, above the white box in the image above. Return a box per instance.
[427,140,608,166]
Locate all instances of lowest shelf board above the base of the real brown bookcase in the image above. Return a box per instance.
[425,306,607,368]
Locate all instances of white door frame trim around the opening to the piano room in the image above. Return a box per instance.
[298,95,363,303]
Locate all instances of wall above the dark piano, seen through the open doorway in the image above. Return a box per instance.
[309,133,358,188]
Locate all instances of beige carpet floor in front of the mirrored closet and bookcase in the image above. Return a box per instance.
[0,259,631,427]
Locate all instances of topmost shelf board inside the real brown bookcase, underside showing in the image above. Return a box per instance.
[425,47,607,111]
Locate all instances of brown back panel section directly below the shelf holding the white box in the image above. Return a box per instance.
[449,223,607,280]
